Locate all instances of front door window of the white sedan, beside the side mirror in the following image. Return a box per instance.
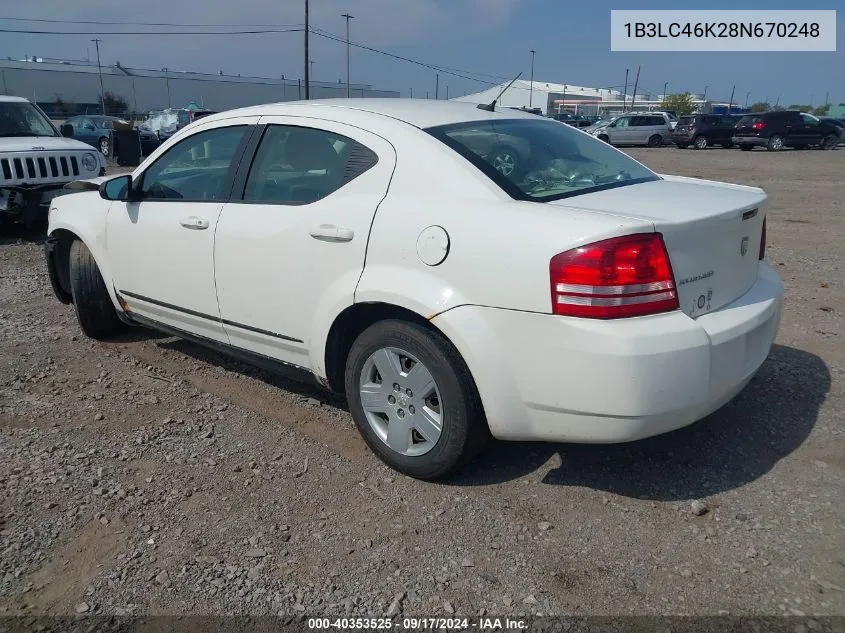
[141,125,246,202]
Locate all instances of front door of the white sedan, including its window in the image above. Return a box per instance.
[106,117,258,342]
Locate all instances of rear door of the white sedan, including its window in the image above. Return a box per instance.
[215,116,396,368]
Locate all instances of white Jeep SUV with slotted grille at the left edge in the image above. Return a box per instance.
[0,95,106,227]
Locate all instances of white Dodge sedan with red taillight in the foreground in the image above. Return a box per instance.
[47,99,783,478]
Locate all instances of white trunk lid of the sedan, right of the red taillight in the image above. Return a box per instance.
[547,176,766,317]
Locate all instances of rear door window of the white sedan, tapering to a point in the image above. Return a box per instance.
[243,125,378,204]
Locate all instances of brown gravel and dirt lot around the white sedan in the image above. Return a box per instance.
[0,148,845,616]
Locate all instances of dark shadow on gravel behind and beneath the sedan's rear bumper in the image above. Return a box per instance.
[444,345,831,501]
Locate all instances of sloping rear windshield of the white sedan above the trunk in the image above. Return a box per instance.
[426,119,660,202]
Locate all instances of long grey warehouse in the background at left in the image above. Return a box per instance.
[0,57,399,115]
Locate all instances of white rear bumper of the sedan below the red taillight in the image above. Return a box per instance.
[432,263,783,443]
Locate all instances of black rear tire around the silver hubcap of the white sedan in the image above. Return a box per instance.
[345,319,490,479]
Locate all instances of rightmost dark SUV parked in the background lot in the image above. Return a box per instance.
[732,110,840,152]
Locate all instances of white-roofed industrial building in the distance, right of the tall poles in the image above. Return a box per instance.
[453,79,724,116]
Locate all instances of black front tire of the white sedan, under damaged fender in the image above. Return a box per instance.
[69,240,126,339]
